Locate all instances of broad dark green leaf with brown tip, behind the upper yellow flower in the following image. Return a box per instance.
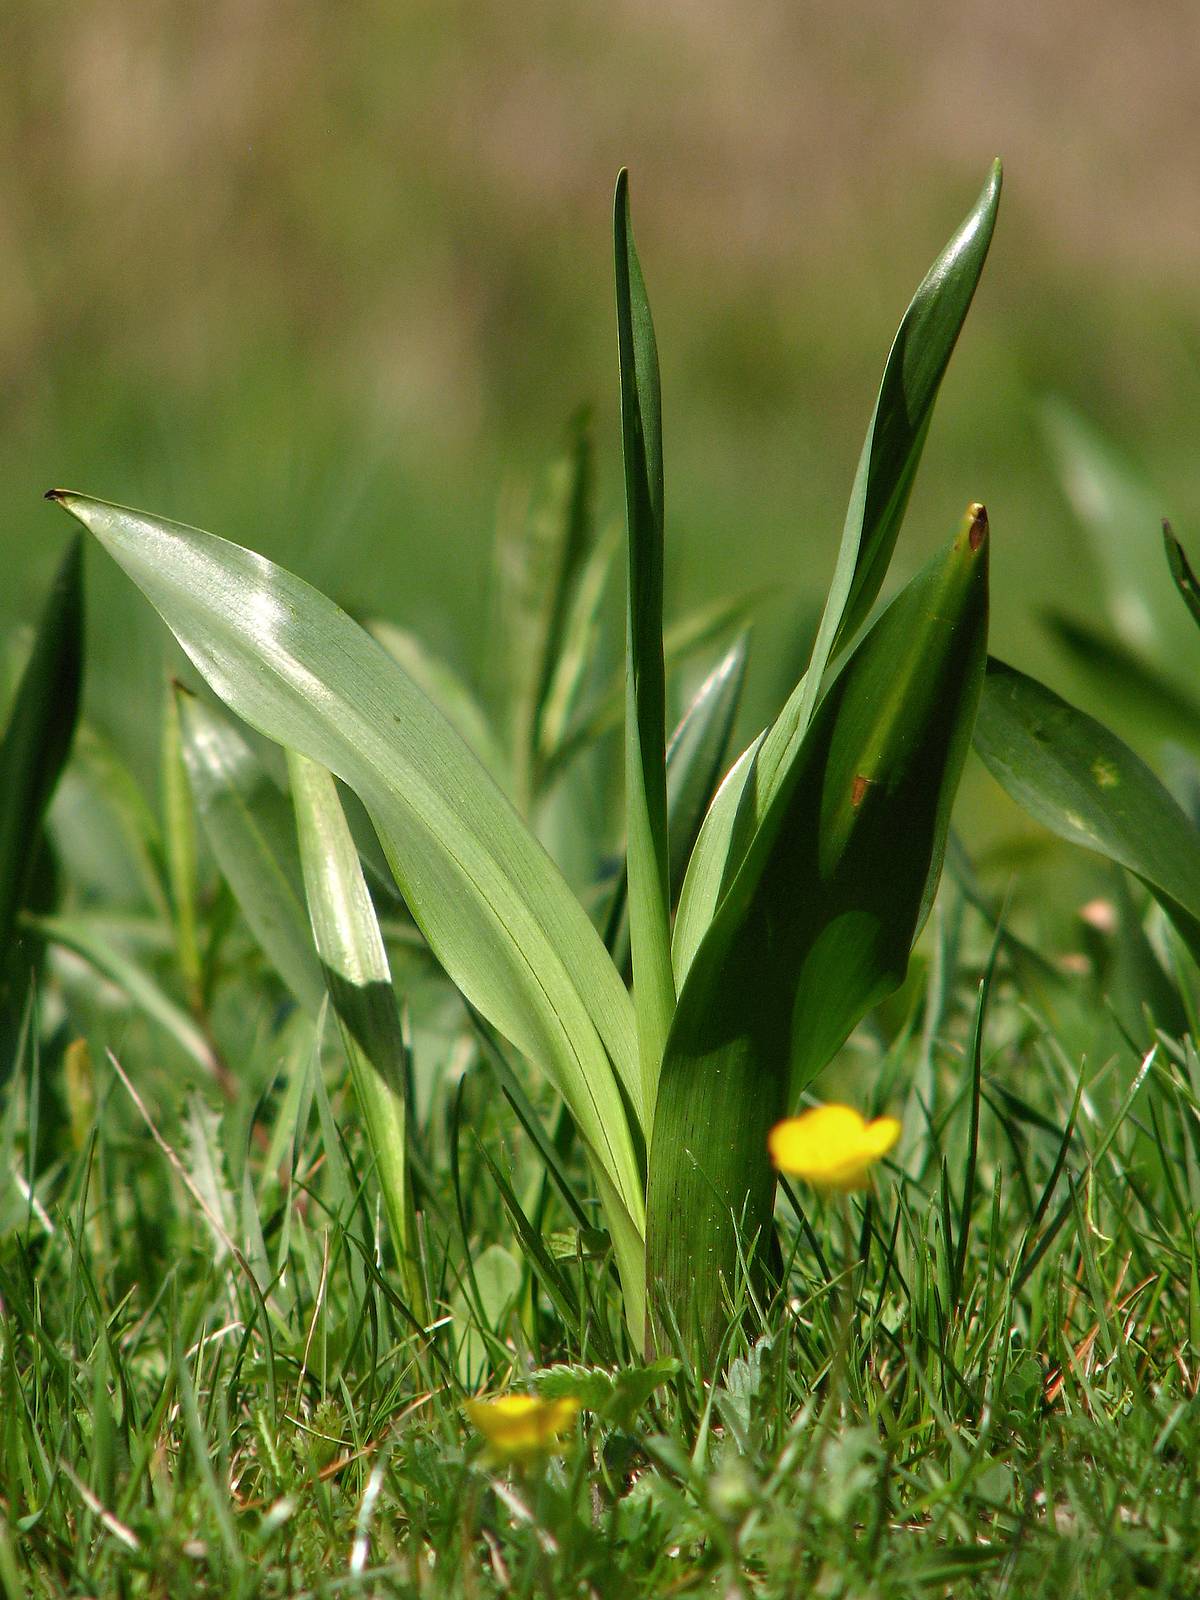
[646,507,987,1358]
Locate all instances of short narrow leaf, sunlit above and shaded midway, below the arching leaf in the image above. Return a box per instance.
[288,750,426,1320]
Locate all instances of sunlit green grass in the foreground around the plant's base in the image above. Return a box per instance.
[0,888,1200,1600]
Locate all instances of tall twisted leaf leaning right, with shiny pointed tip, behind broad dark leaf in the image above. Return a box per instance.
[675,162,1002,981]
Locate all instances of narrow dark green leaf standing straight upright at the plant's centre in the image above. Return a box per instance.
[613,170,675,1123]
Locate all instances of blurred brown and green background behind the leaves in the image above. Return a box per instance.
[0,0,1200,825]
